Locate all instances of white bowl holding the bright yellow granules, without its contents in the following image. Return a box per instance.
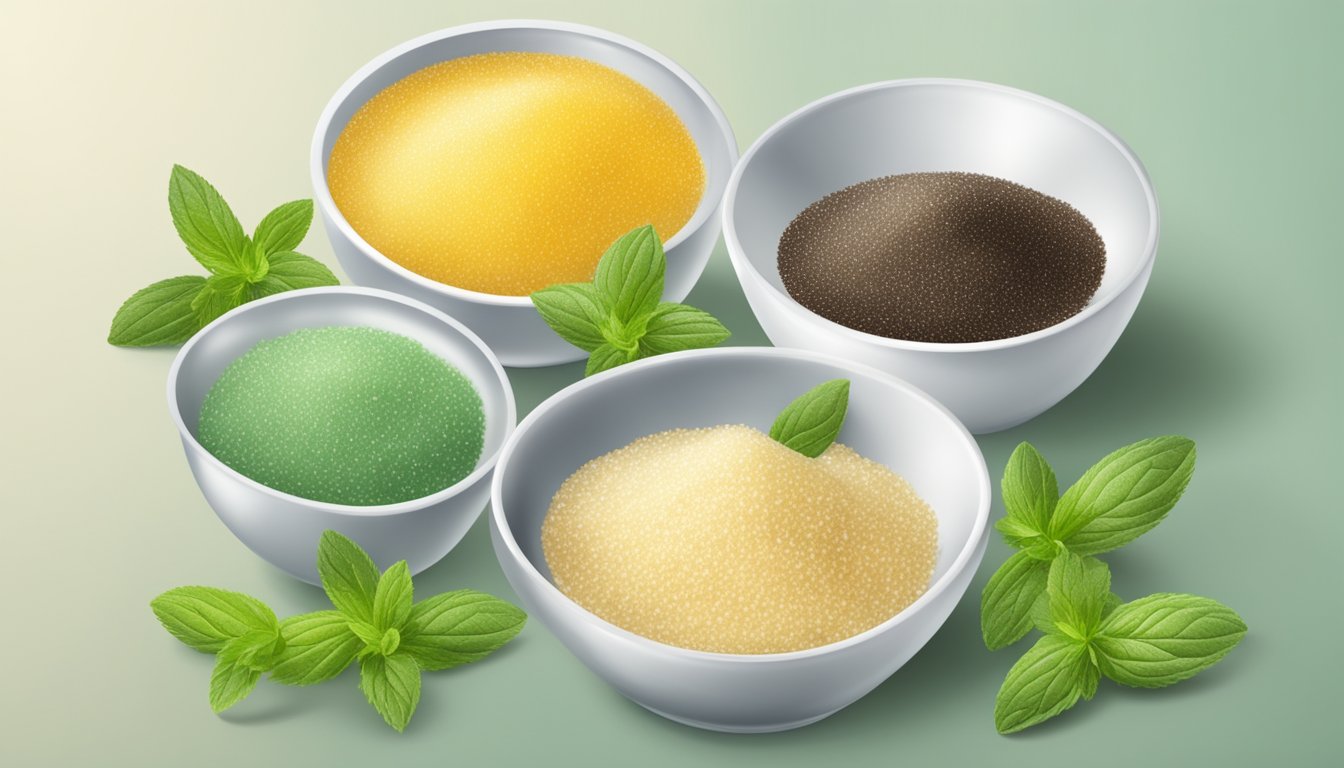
[312,20,738,367]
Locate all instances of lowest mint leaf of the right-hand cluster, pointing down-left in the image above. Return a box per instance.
[995,635,1098,733]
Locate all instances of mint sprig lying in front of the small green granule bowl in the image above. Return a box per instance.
[151,531,527,732]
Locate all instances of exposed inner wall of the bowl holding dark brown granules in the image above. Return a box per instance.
[728,81,1157,316]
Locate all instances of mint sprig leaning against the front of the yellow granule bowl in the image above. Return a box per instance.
[532,226,728,375]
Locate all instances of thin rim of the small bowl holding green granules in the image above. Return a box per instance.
[168,285,517,518]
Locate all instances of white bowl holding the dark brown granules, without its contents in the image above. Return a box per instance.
[723,79,1157,433]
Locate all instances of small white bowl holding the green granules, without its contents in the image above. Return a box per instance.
[168,288,517,584]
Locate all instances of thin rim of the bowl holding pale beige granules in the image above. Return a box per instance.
[491,347,993,664]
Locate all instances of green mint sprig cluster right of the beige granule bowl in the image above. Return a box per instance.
[980,436,1246,733]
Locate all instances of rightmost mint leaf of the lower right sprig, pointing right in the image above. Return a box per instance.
[1093,593,1246,689]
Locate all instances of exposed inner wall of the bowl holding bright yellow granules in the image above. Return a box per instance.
[320,23,737,252]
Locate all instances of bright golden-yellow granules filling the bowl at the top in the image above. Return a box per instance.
[327,52,704,296]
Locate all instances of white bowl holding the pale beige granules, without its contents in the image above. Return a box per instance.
[491,347,991,732]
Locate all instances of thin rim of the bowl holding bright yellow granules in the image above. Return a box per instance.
[309,19,738,307]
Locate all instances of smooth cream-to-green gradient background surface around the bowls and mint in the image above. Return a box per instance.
[0,0,1344,768]
